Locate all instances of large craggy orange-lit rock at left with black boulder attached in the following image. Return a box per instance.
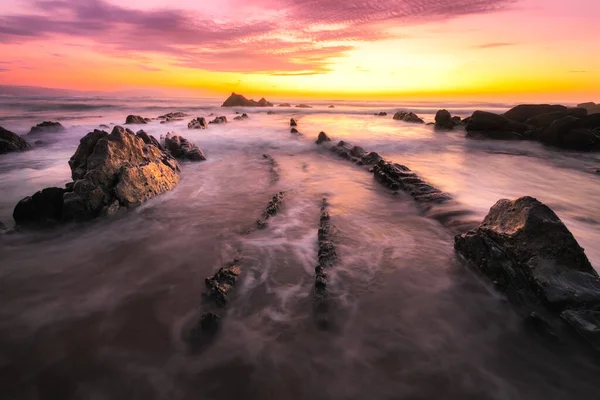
[13,126,180,226]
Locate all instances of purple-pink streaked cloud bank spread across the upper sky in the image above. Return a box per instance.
[0,0,517,75]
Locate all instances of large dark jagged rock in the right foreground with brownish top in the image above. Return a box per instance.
[455,197,600,347]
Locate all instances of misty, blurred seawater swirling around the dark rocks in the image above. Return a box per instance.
[0,98,600,400]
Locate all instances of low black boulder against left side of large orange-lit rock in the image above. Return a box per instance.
[13,187,66,227]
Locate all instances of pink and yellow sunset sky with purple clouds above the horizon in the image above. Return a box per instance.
[0,0,600,102]
